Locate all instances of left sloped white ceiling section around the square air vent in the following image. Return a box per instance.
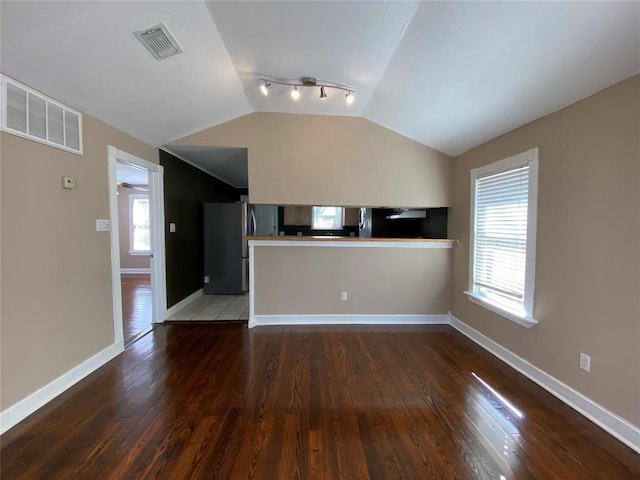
[0,0,252,146]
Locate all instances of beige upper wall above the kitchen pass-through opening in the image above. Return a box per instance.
[175,113,453,207]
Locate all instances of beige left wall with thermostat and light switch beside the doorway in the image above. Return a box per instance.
[0,111,158,410]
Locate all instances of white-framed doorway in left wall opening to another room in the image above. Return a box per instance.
[109,147,166,347]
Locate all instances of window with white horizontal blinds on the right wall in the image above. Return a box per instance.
[468,149,538,324]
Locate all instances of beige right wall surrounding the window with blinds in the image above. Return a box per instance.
[450,76,640,425]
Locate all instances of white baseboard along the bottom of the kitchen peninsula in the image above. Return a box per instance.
[249,314,449,328]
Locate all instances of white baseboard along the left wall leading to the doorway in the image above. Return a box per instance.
[0,342,124,434]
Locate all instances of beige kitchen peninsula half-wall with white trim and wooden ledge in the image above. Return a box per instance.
[248,236,455,328]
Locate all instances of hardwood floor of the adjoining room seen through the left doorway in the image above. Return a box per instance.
[120,274,152,345]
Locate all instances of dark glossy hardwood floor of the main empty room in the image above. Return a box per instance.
[0,324,640,480]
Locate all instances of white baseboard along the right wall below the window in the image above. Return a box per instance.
[450,315,640,453]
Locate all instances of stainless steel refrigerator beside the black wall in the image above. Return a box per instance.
[203,202,255,295]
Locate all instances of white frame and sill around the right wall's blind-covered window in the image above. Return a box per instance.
[464,148,539,328]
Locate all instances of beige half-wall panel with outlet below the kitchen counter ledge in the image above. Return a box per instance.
[254,246,451,315]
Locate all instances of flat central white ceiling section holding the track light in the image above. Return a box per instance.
[207,2,418,116]
